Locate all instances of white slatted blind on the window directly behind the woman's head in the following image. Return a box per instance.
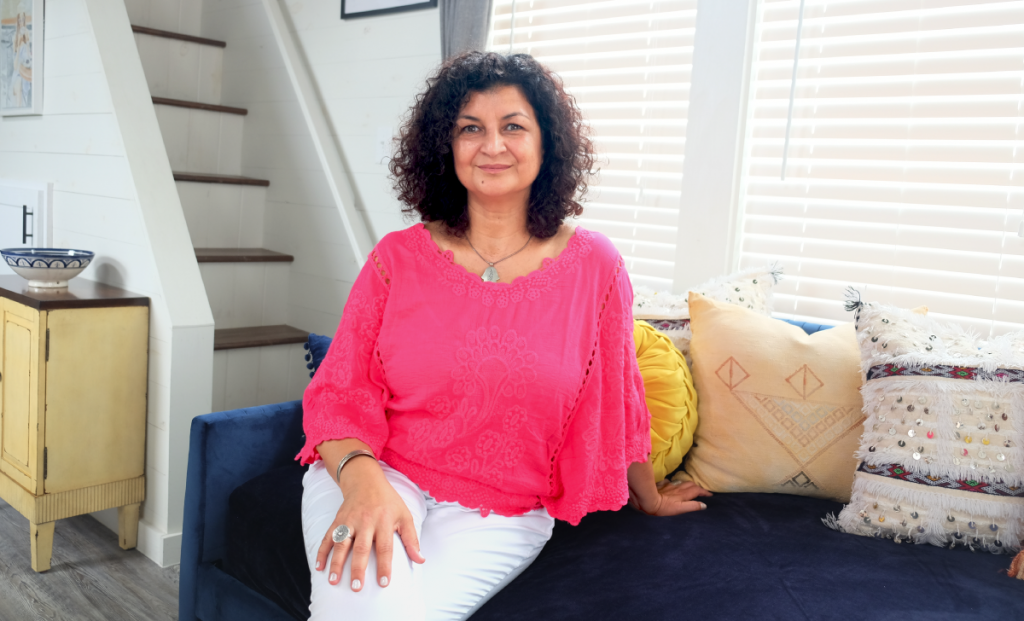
[489,0,697,289]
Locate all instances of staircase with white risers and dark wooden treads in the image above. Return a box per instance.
[127,12,308,411]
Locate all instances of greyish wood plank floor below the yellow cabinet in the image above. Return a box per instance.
[0,500,178,621]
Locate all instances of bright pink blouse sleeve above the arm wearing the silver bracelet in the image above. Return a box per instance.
[296,250,391,465]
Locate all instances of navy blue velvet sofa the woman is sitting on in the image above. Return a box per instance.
[179,325,1024,621]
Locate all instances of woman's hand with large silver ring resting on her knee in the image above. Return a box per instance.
[316,444,424,591]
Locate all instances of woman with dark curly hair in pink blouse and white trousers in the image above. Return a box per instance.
[299,52,707,619]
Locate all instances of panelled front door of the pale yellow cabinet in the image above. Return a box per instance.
[0,299,40,492]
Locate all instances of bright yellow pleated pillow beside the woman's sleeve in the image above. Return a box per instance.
[633,320,697,481]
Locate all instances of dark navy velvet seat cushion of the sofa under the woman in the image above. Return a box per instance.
[225,464,1024,621]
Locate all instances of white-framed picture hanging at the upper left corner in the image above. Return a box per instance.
[0,0,43,117]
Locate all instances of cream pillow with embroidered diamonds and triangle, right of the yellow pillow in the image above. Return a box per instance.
[677,293,863,501]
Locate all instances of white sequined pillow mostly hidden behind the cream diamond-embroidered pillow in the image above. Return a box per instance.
[633,265,782,363]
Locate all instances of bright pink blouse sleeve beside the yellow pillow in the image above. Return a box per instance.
[541,258,650,525]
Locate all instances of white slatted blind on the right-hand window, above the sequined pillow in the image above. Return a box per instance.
[740,0,1024,334]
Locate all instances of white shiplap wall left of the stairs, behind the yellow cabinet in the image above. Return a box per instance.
[0,0,213,564]
